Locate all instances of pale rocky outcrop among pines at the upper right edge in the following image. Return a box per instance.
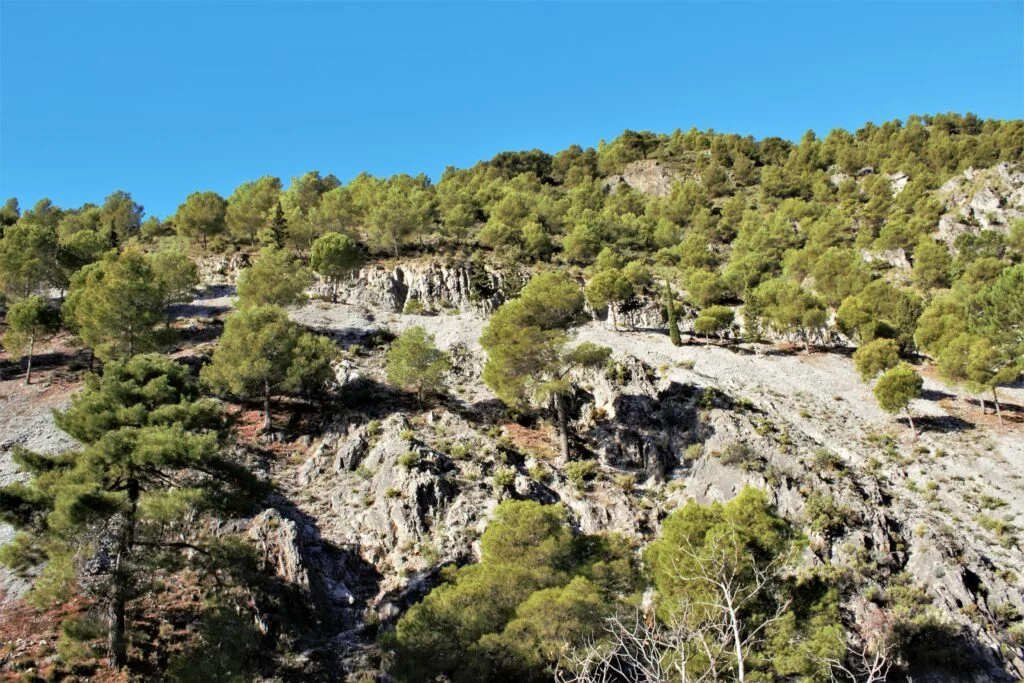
[937,162,1024,248]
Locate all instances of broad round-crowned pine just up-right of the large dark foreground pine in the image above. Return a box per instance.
[203,306,337,431]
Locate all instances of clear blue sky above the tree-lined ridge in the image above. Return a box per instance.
[0,0,1024,216]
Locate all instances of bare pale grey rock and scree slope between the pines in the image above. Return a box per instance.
[2,253,1024,680]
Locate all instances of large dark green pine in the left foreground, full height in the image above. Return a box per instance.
[0,355,263,669]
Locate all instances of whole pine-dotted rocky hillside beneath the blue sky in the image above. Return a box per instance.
[0,115,1024,683]
